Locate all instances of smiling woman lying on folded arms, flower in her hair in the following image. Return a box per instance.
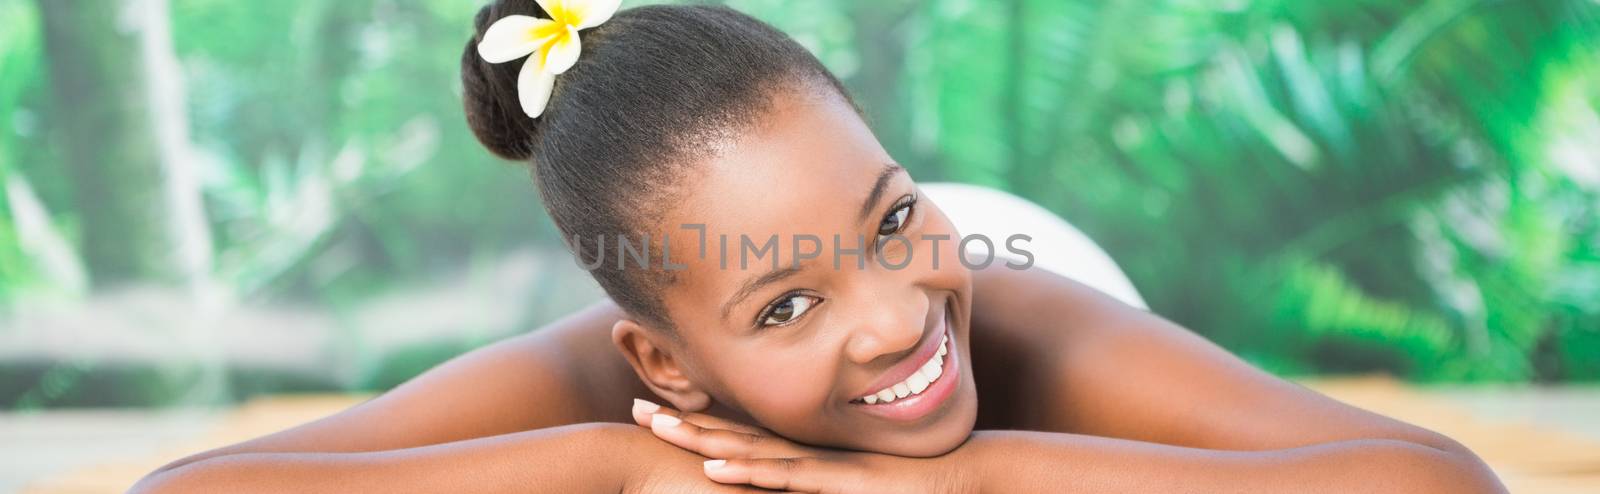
[136,0,1502,492]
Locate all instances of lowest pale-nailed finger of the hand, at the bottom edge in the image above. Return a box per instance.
[706,457,862,492]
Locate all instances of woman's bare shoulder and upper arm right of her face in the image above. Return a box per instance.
[971,267,1459,449]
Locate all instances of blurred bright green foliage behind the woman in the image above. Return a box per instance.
[0,0,1600,404]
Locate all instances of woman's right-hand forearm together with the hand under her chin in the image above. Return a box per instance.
[634,403,1504,492]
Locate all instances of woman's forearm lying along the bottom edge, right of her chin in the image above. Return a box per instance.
[963,432,1504,492]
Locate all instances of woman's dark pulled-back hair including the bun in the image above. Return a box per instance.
[461,0,850,328]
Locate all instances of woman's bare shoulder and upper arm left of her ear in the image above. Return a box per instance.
[154,301,643,468]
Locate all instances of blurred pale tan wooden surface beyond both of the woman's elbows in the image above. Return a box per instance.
[24,377,1600,494]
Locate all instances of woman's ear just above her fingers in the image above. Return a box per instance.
[611,318,710,412]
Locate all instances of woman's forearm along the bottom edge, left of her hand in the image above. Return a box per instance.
[133,424,636,492]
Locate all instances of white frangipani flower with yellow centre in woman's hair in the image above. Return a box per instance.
[478,0,622,118]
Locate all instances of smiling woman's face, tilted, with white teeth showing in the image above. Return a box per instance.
[646,85,978,456]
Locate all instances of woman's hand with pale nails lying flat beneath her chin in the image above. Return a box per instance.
[634,401,976,492]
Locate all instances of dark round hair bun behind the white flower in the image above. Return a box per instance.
[461,0,549,161]
